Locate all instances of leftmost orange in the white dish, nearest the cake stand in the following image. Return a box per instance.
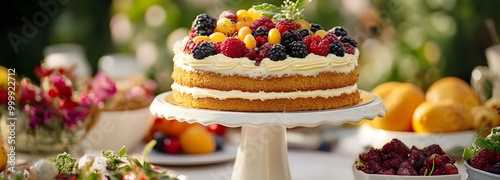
[369,82,425,131]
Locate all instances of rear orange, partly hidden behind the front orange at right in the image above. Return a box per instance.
[425,77,480,110]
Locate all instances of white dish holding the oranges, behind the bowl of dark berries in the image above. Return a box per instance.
[358,124,474,158]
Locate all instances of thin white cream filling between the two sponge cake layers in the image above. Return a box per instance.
[172,83,358,100]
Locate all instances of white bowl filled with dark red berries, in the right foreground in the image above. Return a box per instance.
[352,165,462,180]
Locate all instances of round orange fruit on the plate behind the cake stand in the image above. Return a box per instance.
[179,125,216,154]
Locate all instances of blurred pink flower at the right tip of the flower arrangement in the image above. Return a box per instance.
[91,72,117,101]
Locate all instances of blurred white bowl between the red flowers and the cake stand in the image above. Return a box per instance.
[82,107,154,152]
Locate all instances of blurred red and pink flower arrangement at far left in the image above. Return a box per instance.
[0,65,117,153]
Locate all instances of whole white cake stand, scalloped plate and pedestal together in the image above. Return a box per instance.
[150,91,386,180]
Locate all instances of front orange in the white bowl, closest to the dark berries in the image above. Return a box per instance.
[413,100,472,133]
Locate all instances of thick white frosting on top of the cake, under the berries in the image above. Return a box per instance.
[173,38,359,77]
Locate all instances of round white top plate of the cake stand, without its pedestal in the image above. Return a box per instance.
[149,91,386,128]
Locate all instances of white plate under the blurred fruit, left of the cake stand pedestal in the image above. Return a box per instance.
[146,143,238,166]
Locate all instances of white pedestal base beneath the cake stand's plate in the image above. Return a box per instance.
[231,125,291,180]
